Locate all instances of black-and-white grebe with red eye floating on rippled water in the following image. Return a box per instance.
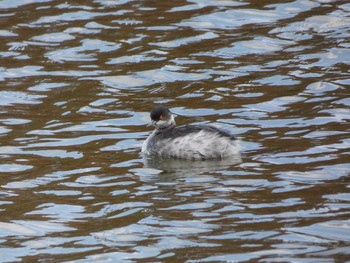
[142,106,240,160]
